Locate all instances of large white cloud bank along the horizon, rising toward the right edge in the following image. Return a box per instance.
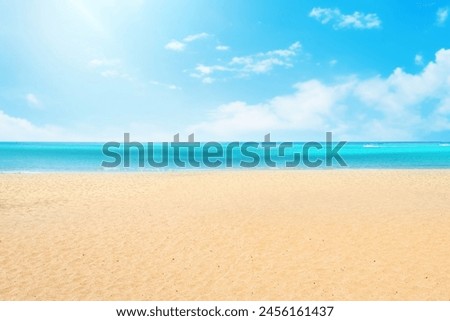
[188,49,450,140]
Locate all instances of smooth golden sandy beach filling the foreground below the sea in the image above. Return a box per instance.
[0,170,450,300]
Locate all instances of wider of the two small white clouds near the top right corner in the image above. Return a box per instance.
[309,7,381,29]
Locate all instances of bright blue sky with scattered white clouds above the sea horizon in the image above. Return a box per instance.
[0,0,450,141]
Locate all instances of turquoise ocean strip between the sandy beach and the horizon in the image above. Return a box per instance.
[0,142,450,173]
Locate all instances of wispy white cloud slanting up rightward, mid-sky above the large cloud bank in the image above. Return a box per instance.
[191,42,301,84]
